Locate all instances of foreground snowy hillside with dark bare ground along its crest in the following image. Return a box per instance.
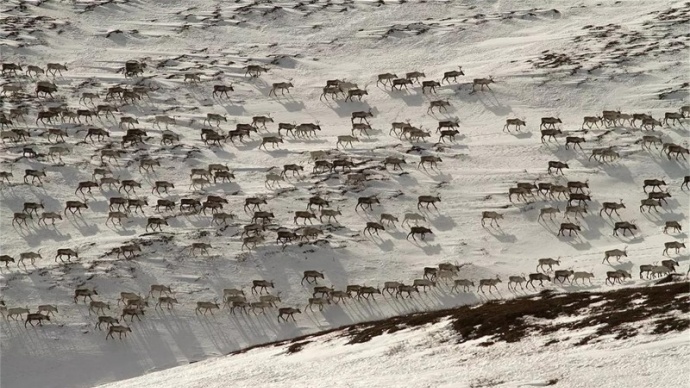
[95,283,690,388]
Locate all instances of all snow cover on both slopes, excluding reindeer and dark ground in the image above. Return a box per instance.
[0,0,690,388]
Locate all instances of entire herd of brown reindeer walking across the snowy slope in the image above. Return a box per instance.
[0,56,690,340]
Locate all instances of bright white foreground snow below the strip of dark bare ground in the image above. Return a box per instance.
[95,322,690,388]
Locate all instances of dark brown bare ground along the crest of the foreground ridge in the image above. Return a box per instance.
[230,281,690,355]
